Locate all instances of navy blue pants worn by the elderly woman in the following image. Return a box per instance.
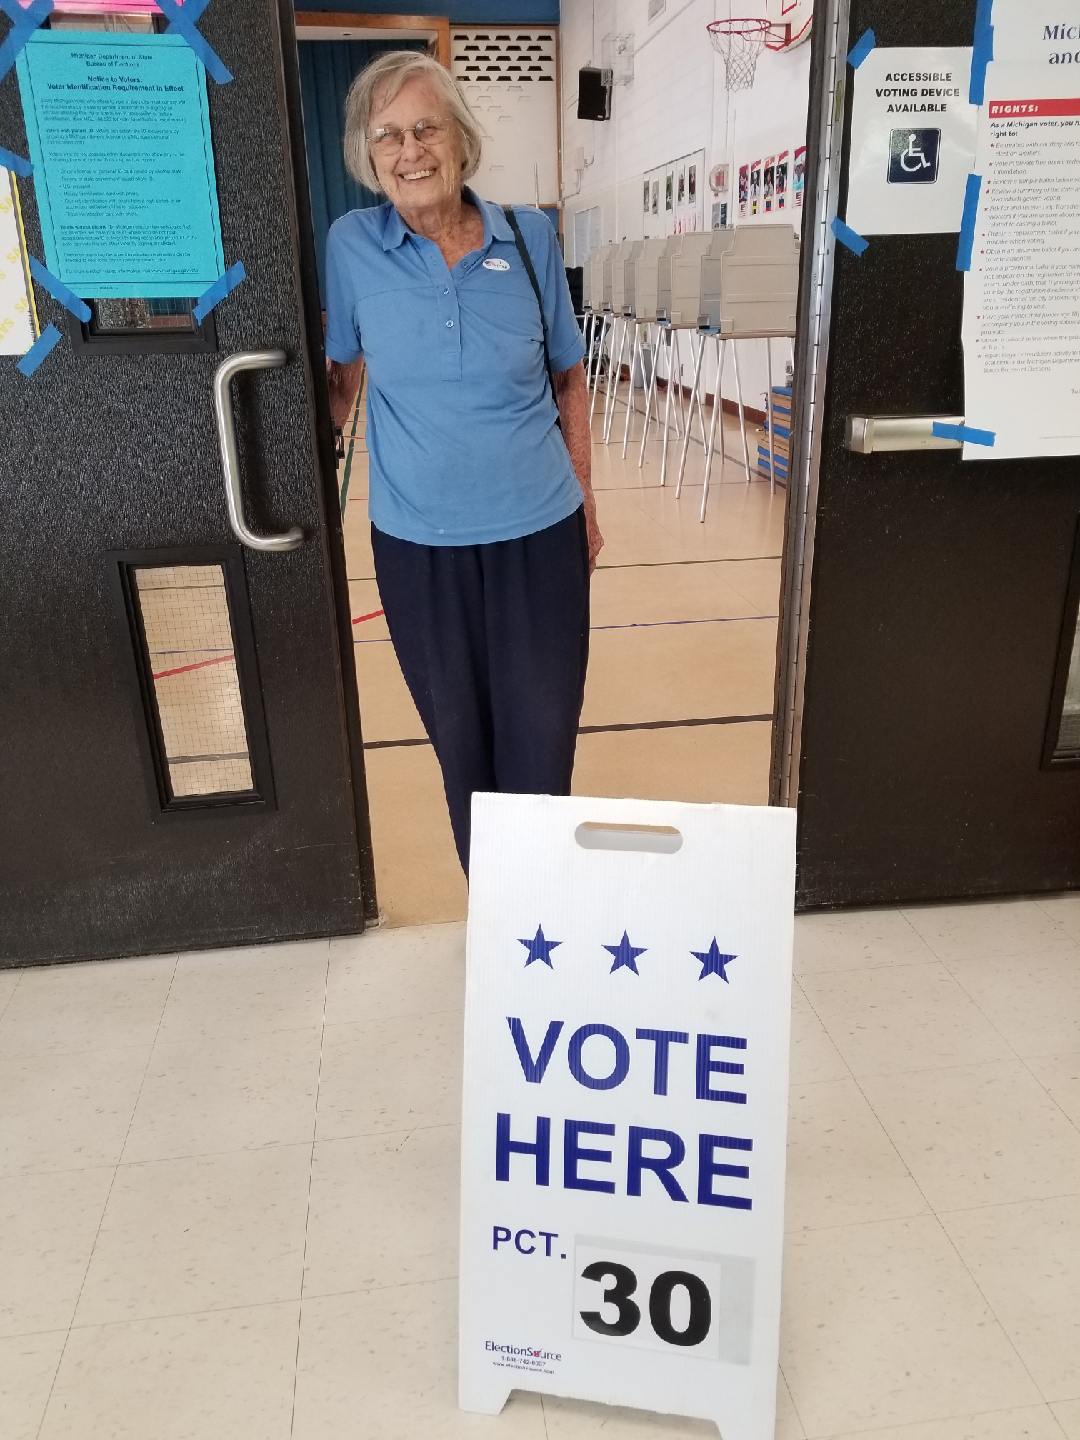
[372,507,589,874]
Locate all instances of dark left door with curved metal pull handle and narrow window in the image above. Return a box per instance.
[0,0,374,965]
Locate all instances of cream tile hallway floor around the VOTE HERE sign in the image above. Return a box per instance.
[0,892,1080,1440]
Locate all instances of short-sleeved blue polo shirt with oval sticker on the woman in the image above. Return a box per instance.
[327,190,585,546]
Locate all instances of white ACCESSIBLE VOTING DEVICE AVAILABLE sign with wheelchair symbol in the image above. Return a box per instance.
[847,46,978,235]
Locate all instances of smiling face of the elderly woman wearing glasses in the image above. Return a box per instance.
[369,76,462,215]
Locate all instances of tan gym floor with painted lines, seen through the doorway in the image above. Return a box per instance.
[341,383,785,924]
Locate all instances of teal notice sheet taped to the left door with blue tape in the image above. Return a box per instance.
[17,30,225,300]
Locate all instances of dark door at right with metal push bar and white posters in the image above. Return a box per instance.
[773,0,1080,906]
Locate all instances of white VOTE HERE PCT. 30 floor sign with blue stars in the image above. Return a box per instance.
[459,795,795,1440]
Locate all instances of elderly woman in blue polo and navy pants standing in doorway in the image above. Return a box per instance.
[327,50,603,873]
